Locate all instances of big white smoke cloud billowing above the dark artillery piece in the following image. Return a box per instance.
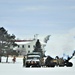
[45,28,75,57]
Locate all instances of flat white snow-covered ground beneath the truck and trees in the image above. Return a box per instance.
[0,57,75,75]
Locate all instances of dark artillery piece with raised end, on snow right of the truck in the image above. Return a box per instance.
[45,51,75,67]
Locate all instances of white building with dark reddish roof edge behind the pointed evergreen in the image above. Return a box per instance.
[13,34,49,55]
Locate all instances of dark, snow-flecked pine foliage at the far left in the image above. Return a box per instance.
[0,27,17,56]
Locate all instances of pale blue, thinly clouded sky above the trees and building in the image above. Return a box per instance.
[0,0,75,38]
